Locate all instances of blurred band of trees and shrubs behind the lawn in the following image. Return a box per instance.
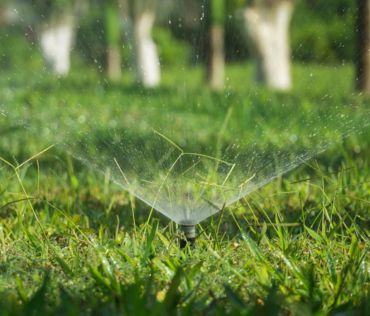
[0,0,368,90]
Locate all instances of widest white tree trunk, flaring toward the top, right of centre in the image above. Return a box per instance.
[244,0,293,90]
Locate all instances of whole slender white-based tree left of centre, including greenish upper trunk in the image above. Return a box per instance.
[128,0,161,87]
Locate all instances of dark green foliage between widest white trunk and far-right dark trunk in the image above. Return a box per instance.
[291,0,356,63]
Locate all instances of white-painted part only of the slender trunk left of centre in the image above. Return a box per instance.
[132,11,161,87]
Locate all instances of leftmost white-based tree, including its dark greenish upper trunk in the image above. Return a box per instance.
[30,0,78,76]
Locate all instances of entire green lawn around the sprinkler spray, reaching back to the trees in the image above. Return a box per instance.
[0,29,370,315]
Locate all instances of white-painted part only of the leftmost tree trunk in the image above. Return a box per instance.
[40,14,75,76]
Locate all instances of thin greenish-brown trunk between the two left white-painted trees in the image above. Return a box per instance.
[104,0,121,81]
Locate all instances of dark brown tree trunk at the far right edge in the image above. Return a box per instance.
[356,0,370,93]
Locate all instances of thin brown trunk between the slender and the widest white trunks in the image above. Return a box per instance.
[207,0,225,90]
